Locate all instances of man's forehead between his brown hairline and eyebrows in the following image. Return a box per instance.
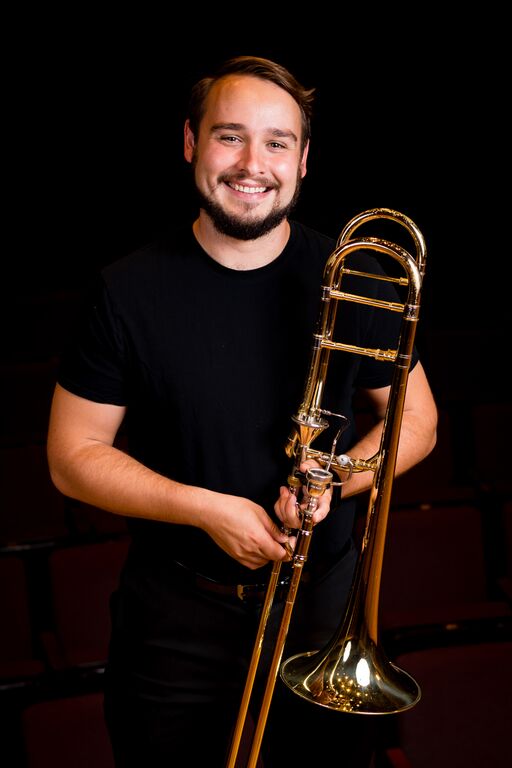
[203,75,302,138]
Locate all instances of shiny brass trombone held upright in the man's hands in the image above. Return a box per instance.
[227,208,426,768]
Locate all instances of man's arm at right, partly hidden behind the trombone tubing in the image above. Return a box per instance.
[275,362,437,526]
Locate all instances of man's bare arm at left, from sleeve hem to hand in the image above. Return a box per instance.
[48,385,287,568]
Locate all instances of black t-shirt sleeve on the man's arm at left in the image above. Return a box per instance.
[57,279,126,405]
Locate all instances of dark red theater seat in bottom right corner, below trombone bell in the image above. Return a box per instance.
[386,642,512,768]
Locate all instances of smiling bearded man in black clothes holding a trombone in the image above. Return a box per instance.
[48,57,436,768]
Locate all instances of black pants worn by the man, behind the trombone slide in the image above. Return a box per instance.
[105,550,374,768]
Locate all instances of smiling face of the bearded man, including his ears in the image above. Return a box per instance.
[185,75,307,240]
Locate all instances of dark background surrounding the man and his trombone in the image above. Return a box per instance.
[0,15,512,768]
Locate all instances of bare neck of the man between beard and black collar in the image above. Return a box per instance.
[192,211,290,270]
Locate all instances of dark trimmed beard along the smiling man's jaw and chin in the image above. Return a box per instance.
[194,171,302,240]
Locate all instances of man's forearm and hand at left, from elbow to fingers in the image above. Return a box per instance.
[51,441,288,568]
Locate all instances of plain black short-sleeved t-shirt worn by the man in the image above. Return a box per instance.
[59,222,416,581]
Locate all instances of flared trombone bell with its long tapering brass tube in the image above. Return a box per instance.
[281,208,425,715]
